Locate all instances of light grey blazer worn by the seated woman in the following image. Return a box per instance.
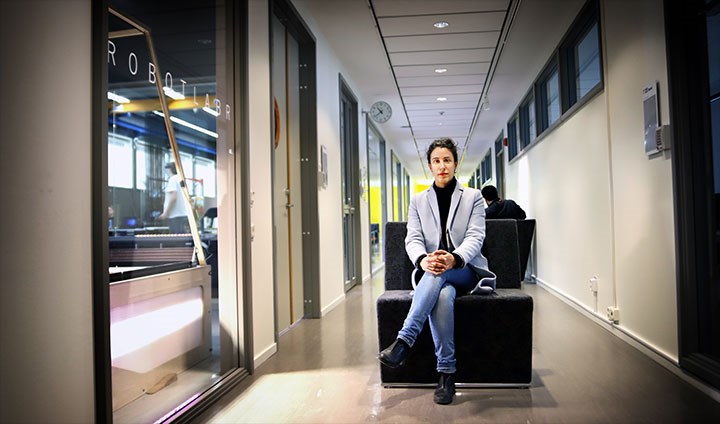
[405,182,495,288]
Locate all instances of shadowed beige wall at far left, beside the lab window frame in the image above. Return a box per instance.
[0,0,95,423]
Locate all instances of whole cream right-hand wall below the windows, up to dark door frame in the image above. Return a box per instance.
[506,0,678,361]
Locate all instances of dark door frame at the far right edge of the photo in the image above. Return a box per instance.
[664,0,720,388]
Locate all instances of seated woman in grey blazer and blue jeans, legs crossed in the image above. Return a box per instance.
[378,138,495,405]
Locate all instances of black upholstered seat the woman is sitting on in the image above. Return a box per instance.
[377,219,533,387]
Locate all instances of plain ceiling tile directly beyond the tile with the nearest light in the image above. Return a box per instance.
[385,31,500,53]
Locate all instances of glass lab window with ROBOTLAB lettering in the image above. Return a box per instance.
[107,0,239,422]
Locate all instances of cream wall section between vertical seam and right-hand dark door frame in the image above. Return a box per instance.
[604,0,678,360]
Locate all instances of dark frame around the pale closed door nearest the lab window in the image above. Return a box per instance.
[268,0,322,318]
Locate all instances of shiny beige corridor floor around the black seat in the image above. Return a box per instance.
[194,272,720,423]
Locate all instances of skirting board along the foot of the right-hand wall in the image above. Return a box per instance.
[535,278,720,402]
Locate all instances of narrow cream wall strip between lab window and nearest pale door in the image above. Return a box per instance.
[248,0,277,367]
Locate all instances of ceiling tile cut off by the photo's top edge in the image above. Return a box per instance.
[373,0,508,17]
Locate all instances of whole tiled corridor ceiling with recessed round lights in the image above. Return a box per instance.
[293,0,583,179]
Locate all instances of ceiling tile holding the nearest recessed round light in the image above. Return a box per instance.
[378,11,505,37]
